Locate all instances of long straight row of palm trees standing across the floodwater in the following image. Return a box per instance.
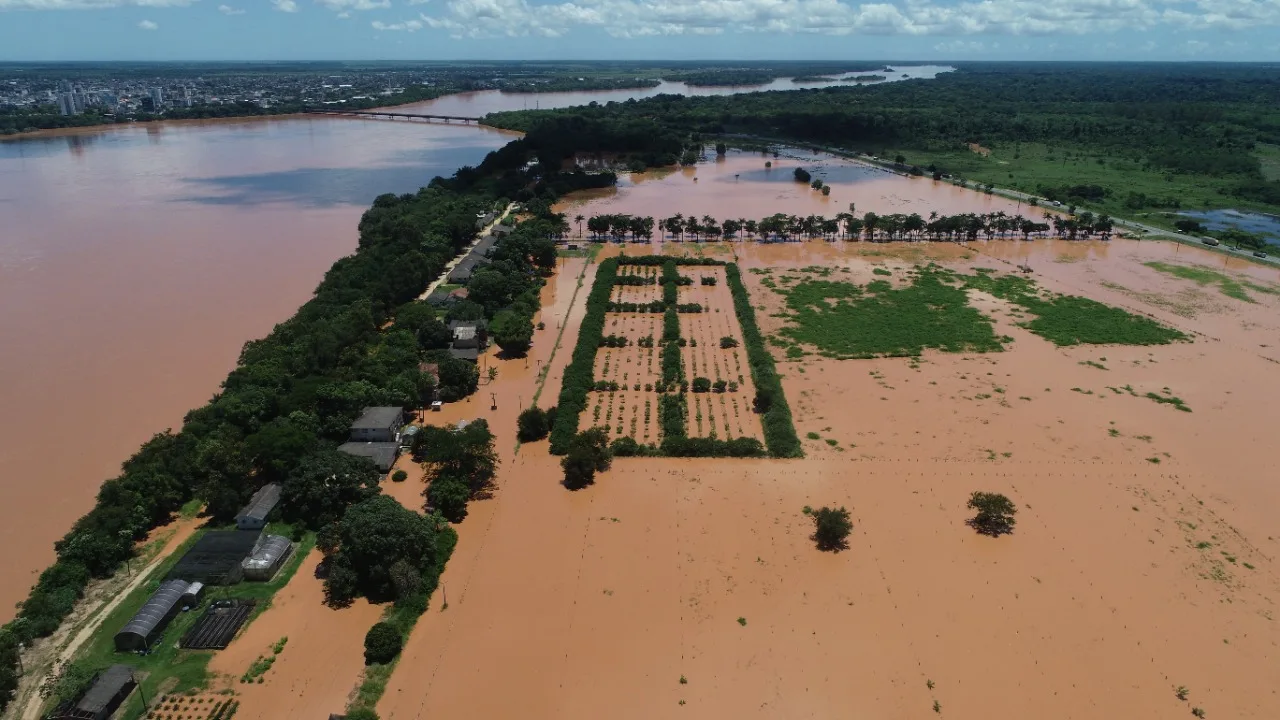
[561,204,1115,242]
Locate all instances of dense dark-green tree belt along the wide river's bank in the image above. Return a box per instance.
[0,113,655,707]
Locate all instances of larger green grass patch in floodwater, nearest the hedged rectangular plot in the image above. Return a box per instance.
[781,265,1004,357]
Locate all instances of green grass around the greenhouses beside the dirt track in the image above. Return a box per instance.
[62,523,315,720]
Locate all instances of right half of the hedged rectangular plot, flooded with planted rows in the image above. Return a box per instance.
[680,266,764,441]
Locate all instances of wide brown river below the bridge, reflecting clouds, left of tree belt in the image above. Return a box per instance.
[0,118,511,620]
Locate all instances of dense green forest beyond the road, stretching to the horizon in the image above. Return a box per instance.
[486,63,1280,214]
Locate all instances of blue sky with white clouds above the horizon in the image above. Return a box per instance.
[0,0,1280,61]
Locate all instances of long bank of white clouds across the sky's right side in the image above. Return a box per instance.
[407,0,1280,38]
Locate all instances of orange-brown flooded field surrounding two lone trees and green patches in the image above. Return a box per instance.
[379,226,1280,719]
